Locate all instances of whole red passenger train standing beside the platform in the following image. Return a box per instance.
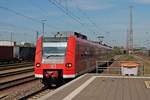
[34,32,112,85]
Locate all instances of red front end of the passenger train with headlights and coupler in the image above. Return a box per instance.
[34,37,75,86]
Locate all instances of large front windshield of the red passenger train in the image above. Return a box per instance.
[43,42,67,58]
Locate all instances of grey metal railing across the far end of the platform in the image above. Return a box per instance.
[96,61,145,76]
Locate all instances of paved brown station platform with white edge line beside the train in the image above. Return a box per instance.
[39,74,150,100]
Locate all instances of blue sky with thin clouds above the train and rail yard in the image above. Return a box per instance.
[0,0,150,47]
